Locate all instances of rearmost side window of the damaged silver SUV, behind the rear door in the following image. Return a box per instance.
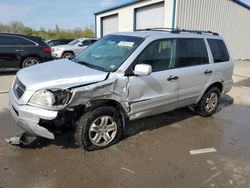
[208,39,229,63]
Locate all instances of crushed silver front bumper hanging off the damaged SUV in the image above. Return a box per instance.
[9,89,58,139]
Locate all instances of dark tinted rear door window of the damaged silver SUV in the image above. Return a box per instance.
[177,38,209,67]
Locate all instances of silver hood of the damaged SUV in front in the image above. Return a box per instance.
[17,59,108,91]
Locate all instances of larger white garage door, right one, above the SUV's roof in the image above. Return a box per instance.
[135,2,164,29]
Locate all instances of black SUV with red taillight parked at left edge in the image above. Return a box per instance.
[0,33,53,71]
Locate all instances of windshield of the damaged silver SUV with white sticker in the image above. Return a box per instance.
[75,35,143,72]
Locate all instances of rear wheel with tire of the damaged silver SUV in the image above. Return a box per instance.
[195,87,220,117]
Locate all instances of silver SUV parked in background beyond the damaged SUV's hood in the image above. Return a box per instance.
[52,38,97,59]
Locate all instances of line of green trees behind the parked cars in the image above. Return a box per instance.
[0,21,95,40]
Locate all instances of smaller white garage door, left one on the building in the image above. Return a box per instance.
[102,14,118,36]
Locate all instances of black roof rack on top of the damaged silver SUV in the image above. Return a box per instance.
[136,27,219,35]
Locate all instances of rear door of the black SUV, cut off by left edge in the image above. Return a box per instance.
[0,35,21,68]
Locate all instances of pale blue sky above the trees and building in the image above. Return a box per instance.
[0,0,250,29]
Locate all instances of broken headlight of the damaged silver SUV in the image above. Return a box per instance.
[29,89,71,109]
